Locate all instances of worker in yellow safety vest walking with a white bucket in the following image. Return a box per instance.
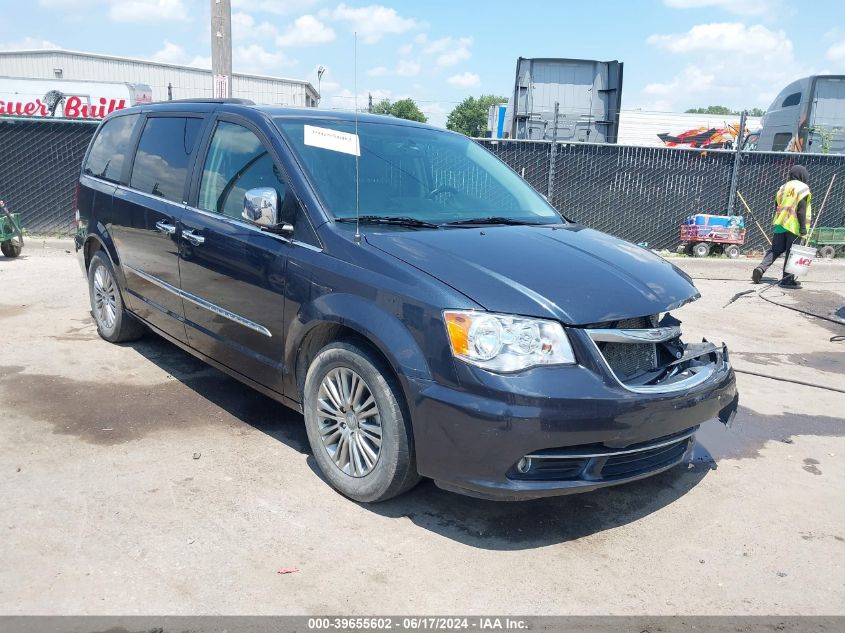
[751,165,812,288]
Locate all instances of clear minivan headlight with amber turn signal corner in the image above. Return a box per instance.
[443,310,575,372]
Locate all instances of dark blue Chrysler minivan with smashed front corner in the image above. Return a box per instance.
[76,100,738,502]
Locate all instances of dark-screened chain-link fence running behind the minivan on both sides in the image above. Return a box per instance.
[0,120,845,250]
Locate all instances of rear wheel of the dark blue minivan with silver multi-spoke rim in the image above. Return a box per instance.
[88,251,144,343]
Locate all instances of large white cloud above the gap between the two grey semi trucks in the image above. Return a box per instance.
[641,22,813,110]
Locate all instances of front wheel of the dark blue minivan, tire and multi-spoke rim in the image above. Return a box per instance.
[303,342,419,503]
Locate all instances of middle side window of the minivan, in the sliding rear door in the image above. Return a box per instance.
[129,117,202,202]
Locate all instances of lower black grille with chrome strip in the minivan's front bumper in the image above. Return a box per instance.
[508,427,697,482]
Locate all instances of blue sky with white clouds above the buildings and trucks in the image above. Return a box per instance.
[0,0,845,125]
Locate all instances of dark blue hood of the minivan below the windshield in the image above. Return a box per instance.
[366,225,700,325]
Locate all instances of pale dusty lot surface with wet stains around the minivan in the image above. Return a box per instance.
[0,239,845,615]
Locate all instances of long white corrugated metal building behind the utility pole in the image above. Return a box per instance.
[0,49,320,108]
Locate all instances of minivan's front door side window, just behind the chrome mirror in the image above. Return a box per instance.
[198,121,295,224]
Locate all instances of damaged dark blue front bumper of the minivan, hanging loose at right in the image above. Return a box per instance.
[409,329,739,500]
